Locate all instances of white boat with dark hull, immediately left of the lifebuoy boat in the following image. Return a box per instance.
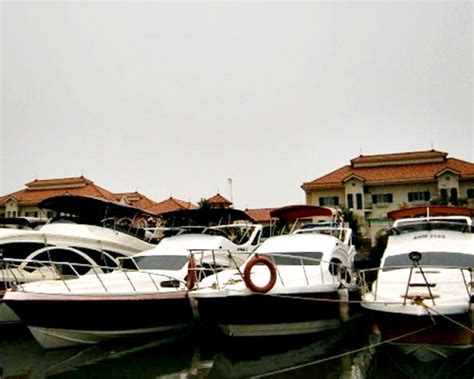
[4,212,261,348]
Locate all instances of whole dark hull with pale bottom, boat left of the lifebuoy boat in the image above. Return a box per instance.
[5,293,194,348]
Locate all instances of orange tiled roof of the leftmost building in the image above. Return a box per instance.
[0,176,116,205]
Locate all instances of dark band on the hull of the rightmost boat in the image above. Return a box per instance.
[368,311,474,345]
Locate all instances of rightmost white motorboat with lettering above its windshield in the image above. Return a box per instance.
[362,207,474,361]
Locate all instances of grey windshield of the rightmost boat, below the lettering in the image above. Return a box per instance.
[383,252,474,268]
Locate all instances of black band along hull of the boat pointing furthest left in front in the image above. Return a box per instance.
[5,297,193,331]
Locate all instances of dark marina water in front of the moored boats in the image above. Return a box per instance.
[0,324,474,379]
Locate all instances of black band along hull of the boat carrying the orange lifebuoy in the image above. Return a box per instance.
[197,292,360,325]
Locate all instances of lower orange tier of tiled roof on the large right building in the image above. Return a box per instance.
[302,154,474,190]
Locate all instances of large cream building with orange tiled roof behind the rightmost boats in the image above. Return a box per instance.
[301,150,474,240]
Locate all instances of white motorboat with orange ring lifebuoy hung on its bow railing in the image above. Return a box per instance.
[190,207,358,337]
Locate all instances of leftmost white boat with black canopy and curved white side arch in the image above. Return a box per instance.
[0,195,159,324]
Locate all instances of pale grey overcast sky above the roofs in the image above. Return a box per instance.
[0,0,474,208]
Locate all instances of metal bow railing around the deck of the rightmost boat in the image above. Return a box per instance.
[357,264,474,305]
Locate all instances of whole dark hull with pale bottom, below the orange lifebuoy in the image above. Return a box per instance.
[197,292,358,337]
